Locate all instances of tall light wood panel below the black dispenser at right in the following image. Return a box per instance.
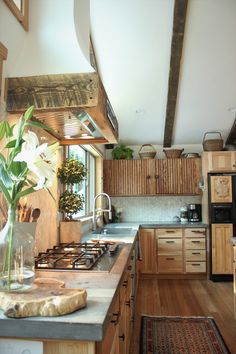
[211,224,233,274]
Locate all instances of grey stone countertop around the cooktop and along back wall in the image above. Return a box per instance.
[0,222,207,341]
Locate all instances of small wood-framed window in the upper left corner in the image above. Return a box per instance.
[4,0,29,31]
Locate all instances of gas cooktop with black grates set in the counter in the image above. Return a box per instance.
[35,242,122,271]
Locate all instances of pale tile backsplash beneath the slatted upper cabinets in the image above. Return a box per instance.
[112,196,201,222]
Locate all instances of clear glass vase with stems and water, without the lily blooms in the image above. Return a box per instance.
[0,209,36,291]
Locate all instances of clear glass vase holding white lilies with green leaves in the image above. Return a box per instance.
[0,106,59,291]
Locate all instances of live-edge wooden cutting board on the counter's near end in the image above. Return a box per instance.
[0,278,87,318]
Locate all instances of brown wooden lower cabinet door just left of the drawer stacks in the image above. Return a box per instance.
[139,229,157,274]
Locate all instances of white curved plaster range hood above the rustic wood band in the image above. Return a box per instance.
[6,0,94,77]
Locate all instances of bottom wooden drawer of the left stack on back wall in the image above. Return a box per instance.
[158,255,183,273]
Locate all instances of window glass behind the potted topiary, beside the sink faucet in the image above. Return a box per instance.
[66,145,96,218]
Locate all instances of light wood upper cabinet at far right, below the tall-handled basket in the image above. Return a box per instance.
[202,151,236,172]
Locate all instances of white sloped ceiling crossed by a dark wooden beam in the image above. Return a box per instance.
[90,0,236,145]
